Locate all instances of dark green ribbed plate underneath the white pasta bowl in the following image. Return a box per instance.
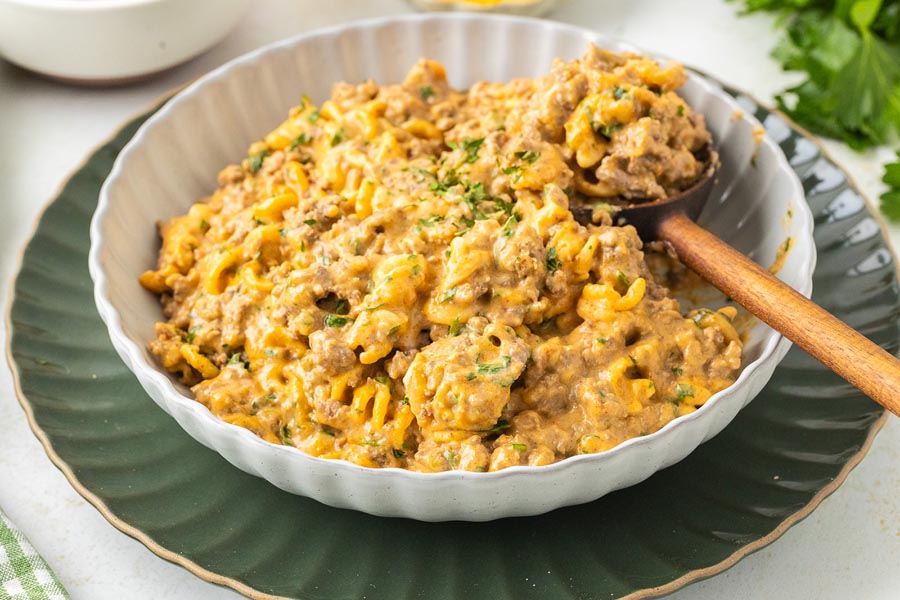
[10,85,900,600]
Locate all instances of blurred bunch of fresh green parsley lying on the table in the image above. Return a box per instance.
[742,0,900,225]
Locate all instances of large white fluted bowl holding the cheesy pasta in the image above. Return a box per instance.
[89,15,815,521]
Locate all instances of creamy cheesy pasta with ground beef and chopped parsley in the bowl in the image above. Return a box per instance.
[140,46,742,472]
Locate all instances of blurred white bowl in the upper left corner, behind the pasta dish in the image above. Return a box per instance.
[0,0,249,84]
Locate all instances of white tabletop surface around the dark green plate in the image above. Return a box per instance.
[0,0,900,600]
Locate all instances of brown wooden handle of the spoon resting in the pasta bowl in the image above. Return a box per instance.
[657,214,900,416]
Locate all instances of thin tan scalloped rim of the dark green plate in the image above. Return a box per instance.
[4,84,900,600]
